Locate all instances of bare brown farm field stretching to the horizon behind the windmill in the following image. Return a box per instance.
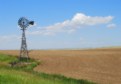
[0,48,121,84]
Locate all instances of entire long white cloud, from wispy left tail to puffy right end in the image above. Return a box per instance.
[28,13,113,35]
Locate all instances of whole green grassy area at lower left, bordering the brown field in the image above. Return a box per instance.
[0,54,94,84]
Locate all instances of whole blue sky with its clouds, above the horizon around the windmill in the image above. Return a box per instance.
[0,0,121,49]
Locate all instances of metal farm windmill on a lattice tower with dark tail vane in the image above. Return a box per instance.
[18,17,34,61]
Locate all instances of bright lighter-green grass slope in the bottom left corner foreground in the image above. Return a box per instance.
[0,69,62,84]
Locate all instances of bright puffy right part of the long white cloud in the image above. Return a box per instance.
[71,13,113,26]
